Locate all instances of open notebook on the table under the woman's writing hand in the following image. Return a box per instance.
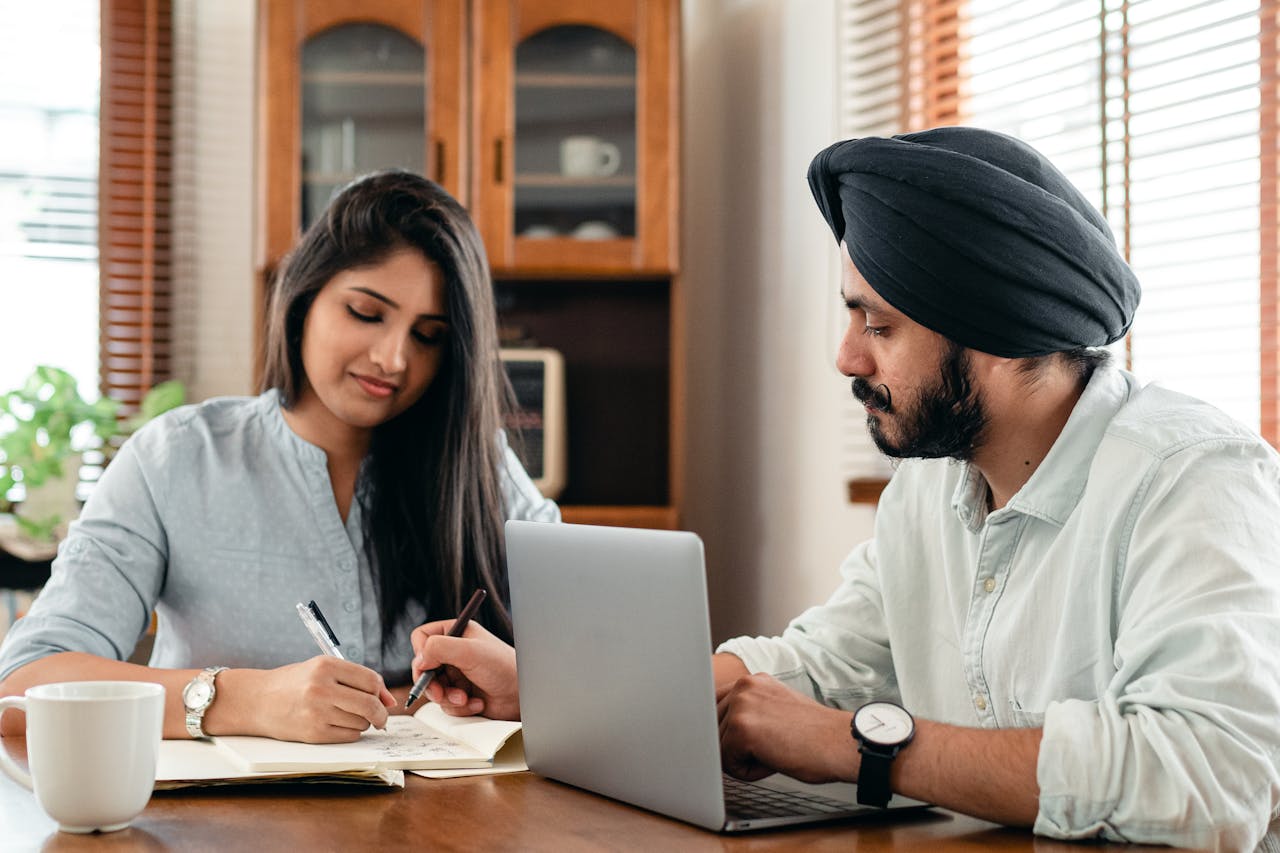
[156,703,520,788]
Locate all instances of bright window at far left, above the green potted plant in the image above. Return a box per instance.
[0,0,99,400]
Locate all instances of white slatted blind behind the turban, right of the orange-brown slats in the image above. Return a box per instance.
[961,0,1276,442]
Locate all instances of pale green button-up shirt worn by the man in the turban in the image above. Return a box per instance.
[721,368,1280,850]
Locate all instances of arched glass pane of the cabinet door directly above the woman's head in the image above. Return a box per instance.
[301,23,426,228]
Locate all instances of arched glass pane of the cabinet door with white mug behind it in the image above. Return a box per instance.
[513,24,637,241]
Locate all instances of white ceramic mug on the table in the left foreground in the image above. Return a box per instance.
[0,681,164,833]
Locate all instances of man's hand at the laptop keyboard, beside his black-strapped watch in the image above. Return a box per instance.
[717,675,860,783]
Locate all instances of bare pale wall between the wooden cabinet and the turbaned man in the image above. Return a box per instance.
[681,0,872,640]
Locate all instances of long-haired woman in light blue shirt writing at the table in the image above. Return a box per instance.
[0,172,559,742]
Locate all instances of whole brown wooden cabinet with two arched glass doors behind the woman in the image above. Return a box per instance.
[259,0,684,526]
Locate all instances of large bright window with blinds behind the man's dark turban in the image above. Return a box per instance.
[841,0,1280,444]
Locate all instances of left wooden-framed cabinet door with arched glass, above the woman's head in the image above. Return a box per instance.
[259,0,470,262]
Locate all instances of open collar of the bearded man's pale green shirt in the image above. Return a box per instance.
[951,365,1137,529]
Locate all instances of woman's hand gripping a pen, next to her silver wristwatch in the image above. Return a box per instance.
[212,654,396,743]
